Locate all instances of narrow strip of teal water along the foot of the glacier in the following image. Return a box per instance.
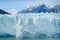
[0,37,60,40]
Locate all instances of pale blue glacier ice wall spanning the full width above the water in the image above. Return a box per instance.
[0,13,60,38]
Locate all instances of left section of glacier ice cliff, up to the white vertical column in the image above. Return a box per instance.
[0,15,16,36]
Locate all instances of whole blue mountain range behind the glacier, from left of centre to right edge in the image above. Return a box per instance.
[18,4,60,13]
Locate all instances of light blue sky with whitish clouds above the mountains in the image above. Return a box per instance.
[0,0,60,11]
